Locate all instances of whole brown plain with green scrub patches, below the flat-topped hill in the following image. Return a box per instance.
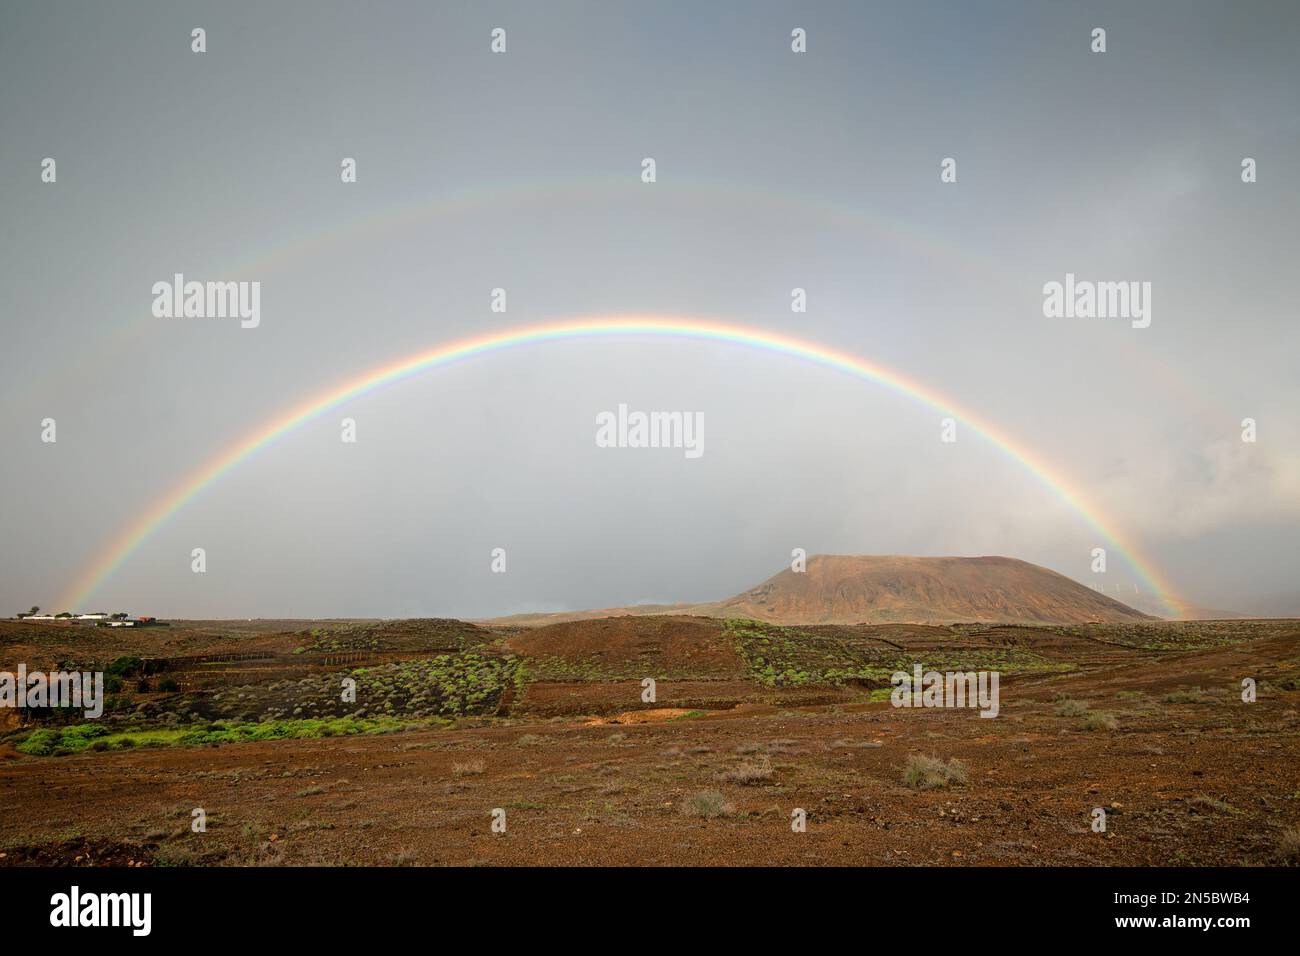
[0,561,1300,866]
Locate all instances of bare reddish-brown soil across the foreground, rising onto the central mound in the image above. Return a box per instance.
[0,618,1300,866]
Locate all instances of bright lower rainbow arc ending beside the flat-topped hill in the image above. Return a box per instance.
[60,315,1177,617]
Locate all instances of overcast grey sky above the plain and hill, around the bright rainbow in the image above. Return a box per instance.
[0,0,1300,617]
